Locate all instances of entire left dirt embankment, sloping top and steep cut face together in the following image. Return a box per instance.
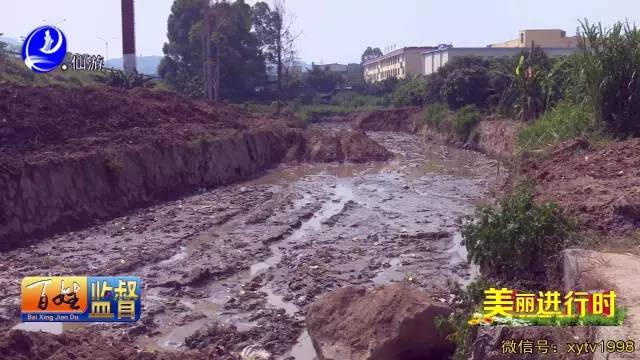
[0,86,391,250]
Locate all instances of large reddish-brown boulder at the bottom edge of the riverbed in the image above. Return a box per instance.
[307,284,454,360]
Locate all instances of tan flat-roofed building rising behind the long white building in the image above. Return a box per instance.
[489,29,578,48]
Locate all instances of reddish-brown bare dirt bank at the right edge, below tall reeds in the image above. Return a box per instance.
[522,139,640,236]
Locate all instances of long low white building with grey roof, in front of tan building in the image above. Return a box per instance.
[422,47,577,76]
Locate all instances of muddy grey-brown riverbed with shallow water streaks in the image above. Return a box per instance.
[0,125,504,360]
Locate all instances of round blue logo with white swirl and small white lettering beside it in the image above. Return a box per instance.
[22,25,104,74]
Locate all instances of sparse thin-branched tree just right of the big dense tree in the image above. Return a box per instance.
[254,0,299,95]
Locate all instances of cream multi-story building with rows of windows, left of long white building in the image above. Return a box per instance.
[364,46,435,83]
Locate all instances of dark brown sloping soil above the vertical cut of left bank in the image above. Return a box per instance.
[0,85,255,160]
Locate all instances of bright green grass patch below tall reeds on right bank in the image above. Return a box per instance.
[518,102,607,150]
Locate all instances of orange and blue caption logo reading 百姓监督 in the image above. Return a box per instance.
[21,276,142,322]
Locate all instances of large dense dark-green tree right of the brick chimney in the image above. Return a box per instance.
[158,0,266,101]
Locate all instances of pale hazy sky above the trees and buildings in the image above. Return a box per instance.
[0,0,640,63]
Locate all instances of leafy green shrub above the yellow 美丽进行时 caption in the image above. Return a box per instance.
[462,186,575,283]
